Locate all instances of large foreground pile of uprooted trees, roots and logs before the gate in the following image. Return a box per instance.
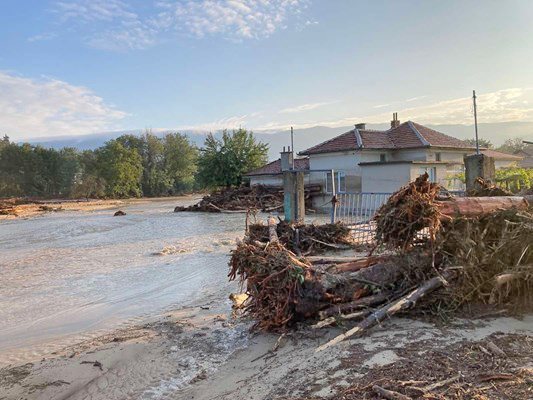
[229,175,533,350]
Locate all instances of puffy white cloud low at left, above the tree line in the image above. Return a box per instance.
[0,71,127,139]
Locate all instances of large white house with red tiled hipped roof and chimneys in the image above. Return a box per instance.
[299,114,510,193]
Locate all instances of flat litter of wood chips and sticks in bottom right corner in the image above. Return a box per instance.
[335,333,533,400]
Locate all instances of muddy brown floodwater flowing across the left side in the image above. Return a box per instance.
[0,199,244,365]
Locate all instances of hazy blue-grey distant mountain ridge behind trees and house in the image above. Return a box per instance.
[19,121,533,160]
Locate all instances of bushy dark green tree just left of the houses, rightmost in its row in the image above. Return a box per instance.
[198,129,268,187]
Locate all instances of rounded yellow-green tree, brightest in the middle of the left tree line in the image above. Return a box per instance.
[96,140,143,198]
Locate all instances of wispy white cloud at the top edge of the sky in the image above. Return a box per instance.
[51,0,309,51]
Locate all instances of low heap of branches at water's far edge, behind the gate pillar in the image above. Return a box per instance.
[174,185,321,213]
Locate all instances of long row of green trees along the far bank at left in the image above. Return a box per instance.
[0,129,268,198]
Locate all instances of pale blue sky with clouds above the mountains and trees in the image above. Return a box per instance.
[0,0,533,140]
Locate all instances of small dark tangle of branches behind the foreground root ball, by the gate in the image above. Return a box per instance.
[247,221,355,254]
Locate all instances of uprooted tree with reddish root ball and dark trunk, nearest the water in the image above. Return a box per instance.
[228,222,404,331]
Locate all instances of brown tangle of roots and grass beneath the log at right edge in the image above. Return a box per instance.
[436,210,533,306]
